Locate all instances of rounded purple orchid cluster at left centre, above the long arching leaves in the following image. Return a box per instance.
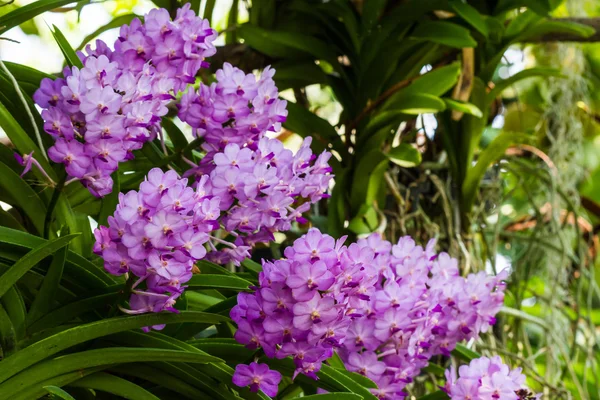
[94,168,220,329]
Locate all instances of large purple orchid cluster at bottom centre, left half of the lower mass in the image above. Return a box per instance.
[230,228,374,379]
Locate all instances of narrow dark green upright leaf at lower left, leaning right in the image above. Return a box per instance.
[27,246,68,325]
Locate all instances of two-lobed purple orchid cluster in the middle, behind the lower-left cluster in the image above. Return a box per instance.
[178,63,333,264]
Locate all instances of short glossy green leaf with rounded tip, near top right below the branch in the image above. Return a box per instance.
[411,21,477,49]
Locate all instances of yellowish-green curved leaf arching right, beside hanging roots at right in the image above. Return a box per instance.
[462,131,531,209]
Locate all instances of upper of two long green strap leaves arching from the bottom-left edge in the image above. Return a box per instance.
[0,311,229,382]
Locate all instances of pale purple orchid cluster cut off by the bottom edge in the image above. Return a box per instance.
[443,356,541,400]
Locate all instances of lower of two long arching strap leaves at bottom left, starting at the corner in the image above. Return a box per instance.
[0,347,221,400]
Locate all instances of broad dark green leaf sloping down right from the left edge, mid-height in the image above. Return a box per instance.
[0,161,46,235]
